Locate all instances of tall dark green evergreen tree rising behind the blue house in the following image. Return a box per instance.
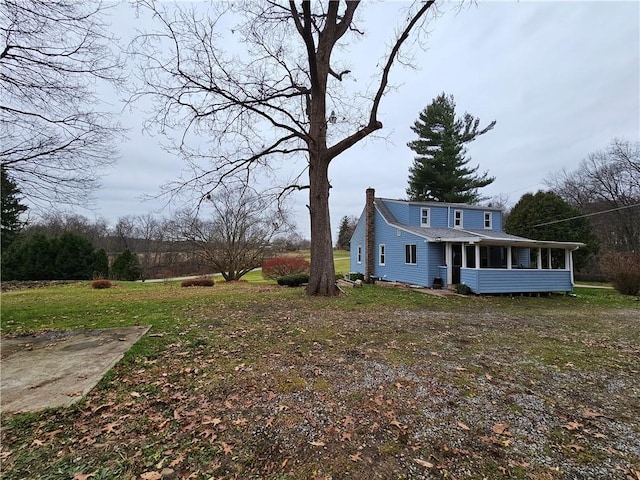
[407,93,496,203]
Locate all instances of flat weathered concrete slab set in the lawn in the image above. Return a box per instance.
[0,326,151,413]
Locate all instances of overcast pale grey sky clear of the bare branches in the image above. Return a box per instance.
[78,1,640,239]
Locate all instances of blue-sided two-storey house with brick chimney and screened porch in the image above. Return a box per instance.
[350,188,584,294]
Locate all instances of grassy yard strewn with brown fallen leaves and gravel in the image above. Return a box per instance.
[0,282,640,480]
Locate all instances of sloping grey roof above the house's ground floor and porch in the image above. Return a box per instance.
[374,198,584,249]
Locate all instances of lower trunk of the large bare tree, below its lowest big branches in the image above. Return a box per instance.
[307,154,338,296]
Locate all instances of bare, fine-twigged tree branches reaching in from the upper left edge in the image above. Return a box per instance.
[0,0,123,207]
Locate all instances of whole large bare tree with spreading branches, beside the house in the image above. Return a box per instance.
[133,0,435,296]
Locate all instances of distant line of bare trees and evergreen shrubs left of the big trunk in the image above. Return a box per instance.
[2,189,308,281]
